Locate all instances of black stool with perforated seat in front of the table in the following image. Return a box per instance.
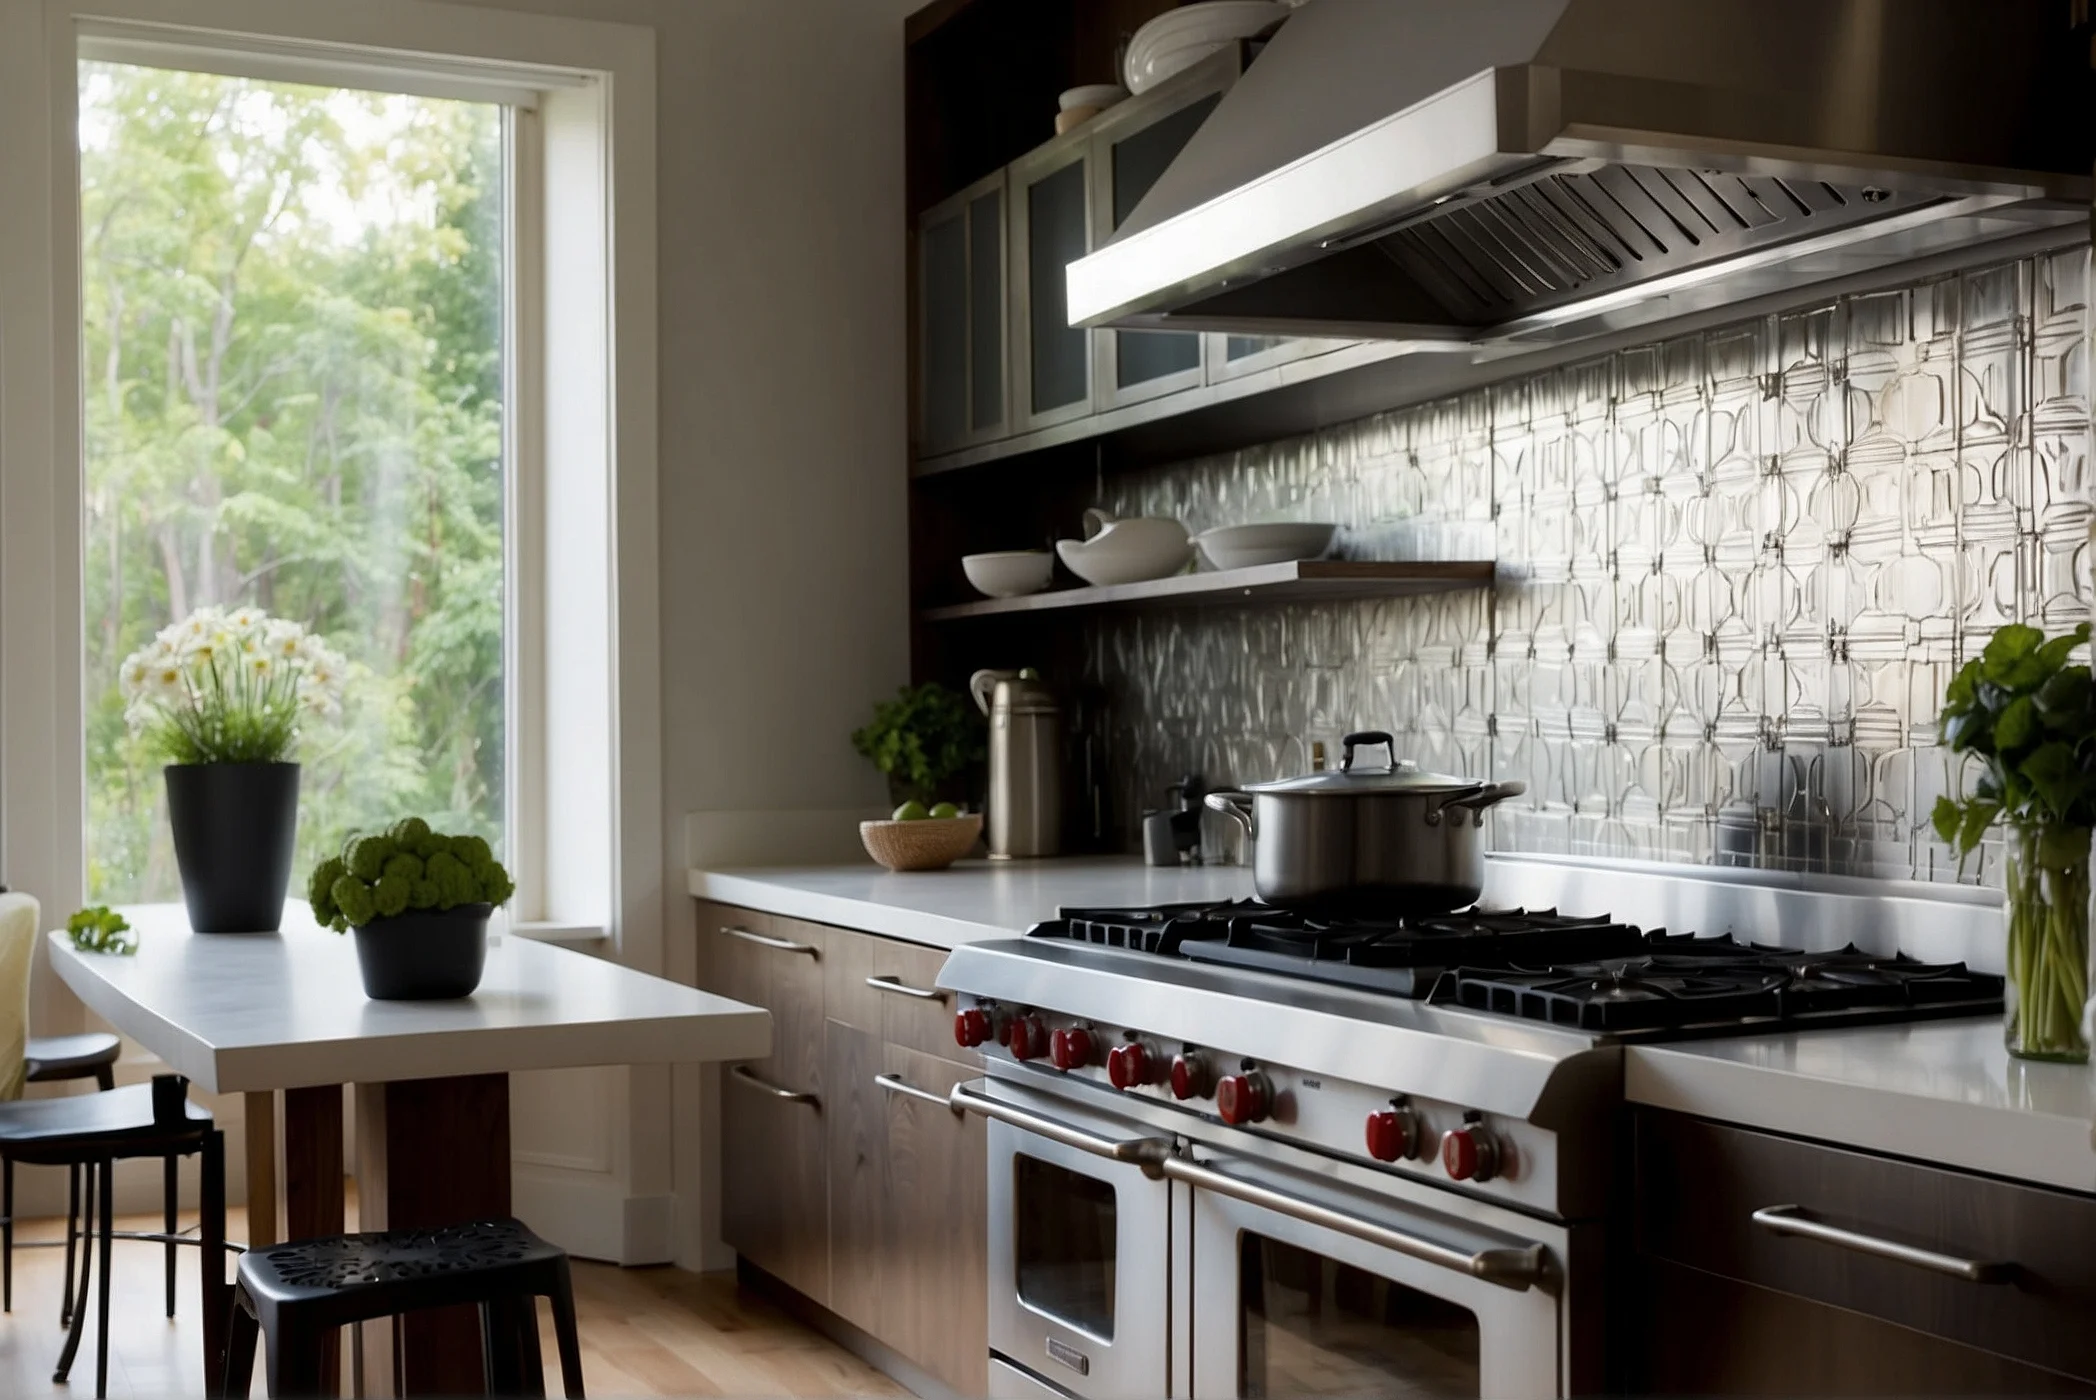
[220,1220,583,1400]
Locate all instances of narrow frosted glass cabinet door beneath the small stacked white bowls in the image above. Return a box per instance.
[1006,134,1092,432]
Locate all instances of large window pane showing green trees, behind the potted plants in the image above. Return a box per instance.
[80,59,518,903]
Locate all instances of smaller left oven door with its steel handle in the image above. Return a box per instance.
[954,1079,1172,1400]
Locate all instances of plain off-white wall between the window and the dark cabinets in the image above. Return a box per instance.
[450,0,922,1266]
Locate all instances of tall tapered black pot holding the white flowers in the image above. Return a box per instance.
[161,763,298,933]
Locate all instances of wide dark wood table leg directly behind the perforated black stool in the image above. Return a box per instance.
[356,1075,511,1396]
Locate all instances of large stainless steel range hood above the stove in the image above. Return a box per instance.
[1069,0,2092,348]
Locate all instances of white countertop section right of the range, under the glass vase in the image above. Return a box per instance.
[1624,1016,2096,1193]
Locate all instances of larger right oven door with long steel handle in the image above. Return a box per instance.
[1174,1151,1564,1398]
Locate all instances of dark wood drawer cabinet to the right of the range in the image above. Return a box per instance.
[1626,1111,2096,1396]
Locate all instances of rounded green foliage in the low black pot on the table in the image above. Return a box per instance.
[306,817,516,933]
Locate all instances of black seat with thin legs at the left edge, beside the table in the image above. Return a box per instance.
[0,1075,226,1400]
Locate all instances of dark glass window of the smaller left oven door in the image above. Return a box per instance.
[1012,1153,1117,1341]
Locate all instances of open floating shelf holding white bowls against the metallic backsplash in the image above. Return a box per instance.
[920,560,1492,622]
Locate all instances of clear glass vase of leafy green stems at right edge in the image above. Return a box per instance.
[1935,622,2096,1063]
